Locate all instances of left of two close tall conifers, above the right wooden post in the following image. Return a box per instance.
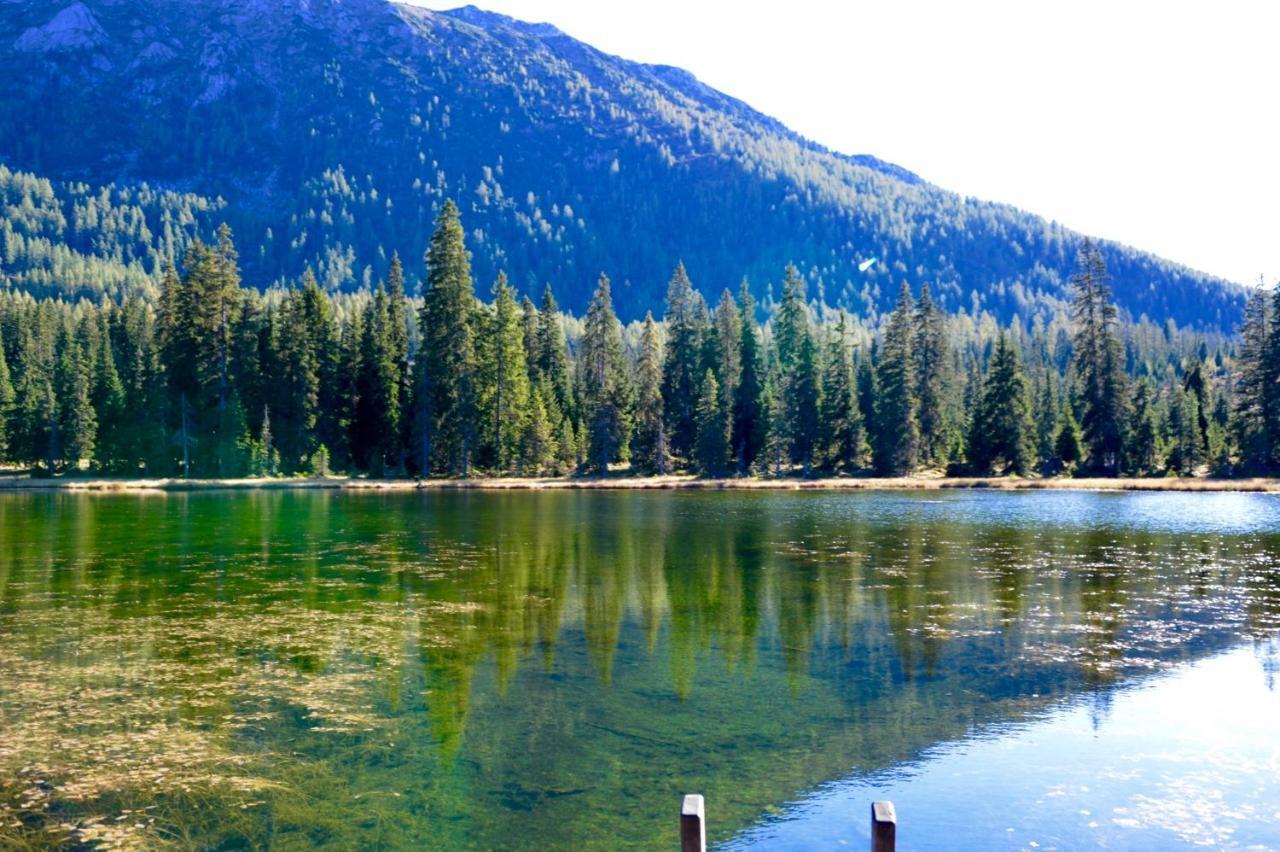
[873,283,919,476]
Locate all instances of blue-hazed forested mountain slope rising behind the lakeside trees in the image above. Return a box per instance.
[0,0,1244,329]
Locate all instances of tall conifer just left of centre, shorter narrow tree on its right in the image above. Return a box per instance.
[579,275,631,476]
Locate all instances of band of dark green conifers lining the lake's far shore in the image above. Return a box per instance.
[0,202,1264,477]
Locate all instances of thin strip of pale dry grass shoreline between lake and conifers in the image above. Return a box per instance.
[0,475,1280,494]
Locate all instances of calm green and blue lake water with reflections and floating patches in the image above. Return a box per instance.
[0,491,1280,849]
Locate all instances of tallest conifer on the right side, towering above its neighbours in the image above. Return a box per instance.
[1071,241,1125,473]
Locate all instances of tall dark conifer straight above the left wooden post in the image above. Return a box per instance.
[662,264,708,458]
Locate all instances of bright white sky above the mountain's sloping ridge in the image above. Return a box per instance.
[411,0,1280,285]
